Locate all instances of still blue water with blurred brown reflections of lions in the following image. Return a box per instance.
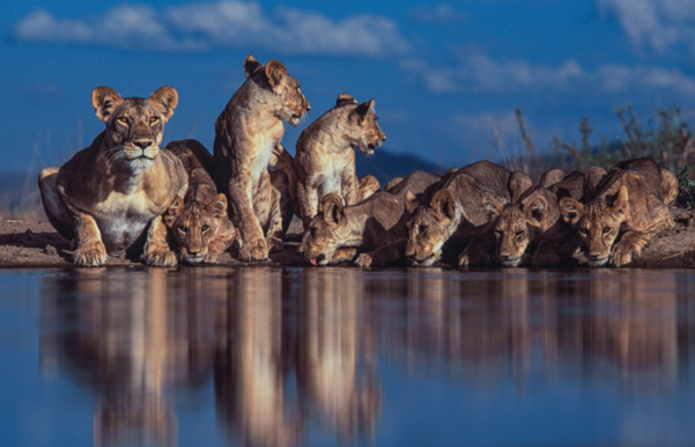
[0,267,695,446]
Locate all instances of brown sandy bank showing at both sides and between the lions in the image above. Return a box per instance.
[0,208,695,269]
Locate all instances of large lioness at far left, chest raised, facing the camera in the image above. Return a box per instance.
[39,86,188,266]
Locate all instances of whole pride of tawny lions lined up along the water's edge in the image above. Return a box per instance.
[39,55,678,267]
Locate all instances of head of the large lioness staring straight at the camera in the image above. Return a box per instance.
[92,86,178,172]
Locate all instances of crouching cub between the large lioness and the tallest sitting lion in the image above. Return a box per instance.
[164,140,236,264]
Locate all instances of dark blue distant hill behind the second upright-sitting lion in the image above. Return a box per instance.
[355,148,446,188]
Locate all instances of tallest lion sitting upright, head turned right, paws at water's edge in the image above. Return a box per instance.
[213,55,309,261]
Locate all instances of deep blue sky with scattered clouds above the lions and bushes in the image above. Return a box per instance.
[0,0,695,171]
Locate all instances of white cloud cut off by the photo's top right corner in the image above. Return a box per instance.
[597,0,695,53]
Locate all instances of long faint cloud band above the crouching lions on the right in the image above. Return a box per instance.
[408,54,695,97]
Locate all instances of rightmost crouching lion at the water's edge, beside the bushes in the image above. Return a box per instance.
[560,158,678,267]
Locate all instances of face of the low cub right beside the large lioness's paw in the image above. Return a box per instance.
[164,194,227,264]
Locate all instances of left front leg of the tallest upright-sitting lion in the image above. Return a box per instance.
[229,181,268,262]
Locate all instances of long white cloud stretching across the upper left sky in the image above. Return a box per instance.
[14,0,409,56]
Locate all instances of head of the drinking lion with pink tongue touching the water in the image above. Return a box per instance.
[299,194,349,265]
